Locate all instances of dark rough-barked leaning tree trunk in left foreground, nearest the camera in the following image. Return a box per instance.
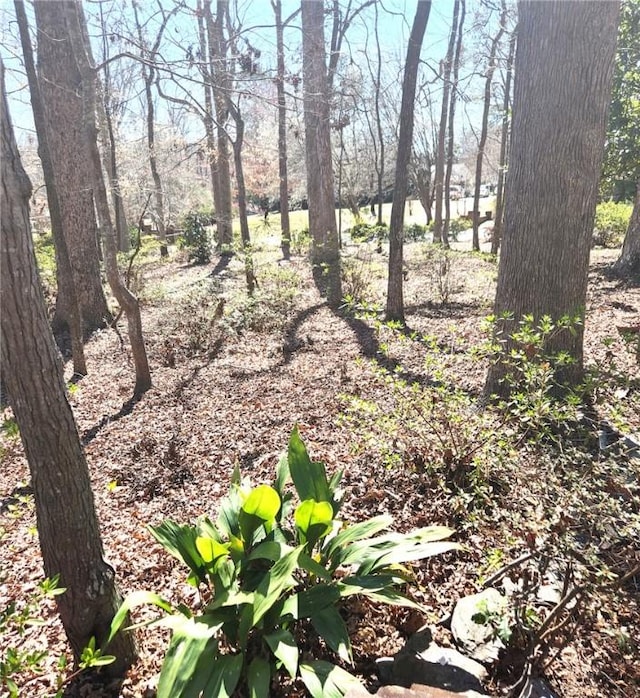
[0,61,136,676]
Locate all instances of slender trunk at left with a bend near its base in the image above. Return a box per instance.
[66,3,151,398]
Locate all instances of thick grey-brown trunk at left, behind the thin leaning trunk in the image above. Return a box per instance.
[34,0,111,334]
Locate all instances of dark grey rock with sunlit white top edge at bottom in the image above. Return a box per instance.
[393,642,487,693]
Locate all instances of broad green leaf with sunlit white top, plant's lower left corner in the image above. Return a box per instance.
[158,619,220,698]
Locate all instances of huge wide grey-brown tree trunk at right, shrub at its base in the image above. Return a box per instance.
[485,2,619,395]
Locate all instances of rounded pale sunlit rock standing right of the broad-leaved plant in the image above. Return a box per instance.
[451,588,508,663]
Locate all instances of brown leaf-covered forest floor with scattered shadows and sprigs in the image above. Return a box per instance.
[0,235,640,698]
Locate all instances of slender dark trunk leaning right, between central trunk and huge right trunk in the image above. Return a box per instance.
[386,0,431,322]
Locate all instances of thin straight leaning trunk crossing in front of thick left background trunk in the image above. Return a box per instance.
[14,0,87,376]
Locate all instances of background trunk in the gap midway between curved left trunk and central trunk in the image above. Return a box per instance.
[203,0,233,252]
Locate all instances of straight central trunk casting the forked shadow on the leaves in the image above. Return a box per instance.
[301,0,342,308]
